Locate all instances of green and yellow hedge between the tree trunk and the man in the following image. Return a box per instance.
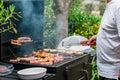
[68,0,101,80]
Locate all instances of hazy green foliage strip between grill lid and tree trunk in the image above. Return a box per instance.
[44,0,56,48]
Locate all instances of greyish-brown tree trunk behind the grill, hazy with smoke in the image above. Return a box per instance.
[53,0,75,44]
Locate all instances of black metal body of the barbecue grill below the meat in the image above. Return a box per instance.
[2,47,91,80]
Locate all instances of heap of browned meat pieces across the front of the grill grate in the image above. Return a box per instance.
[10,50,79,65]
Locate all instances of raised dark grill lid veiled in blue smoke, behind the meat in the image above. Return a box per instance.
[1,0,44,58]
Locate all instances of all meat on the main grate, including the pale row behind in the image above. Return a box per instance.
[10,49,83,65]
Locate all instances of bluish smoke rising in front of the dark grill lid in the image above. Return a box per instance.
[14,0,44,53]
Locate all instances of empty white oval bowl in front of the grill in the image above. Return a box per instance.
[17,67,47,80]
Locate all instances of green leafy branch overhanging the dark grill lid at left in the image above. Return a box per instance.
[0,0,21,33]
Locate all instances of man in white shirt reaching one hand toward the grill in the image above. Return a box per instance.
[81,0,120,80]
